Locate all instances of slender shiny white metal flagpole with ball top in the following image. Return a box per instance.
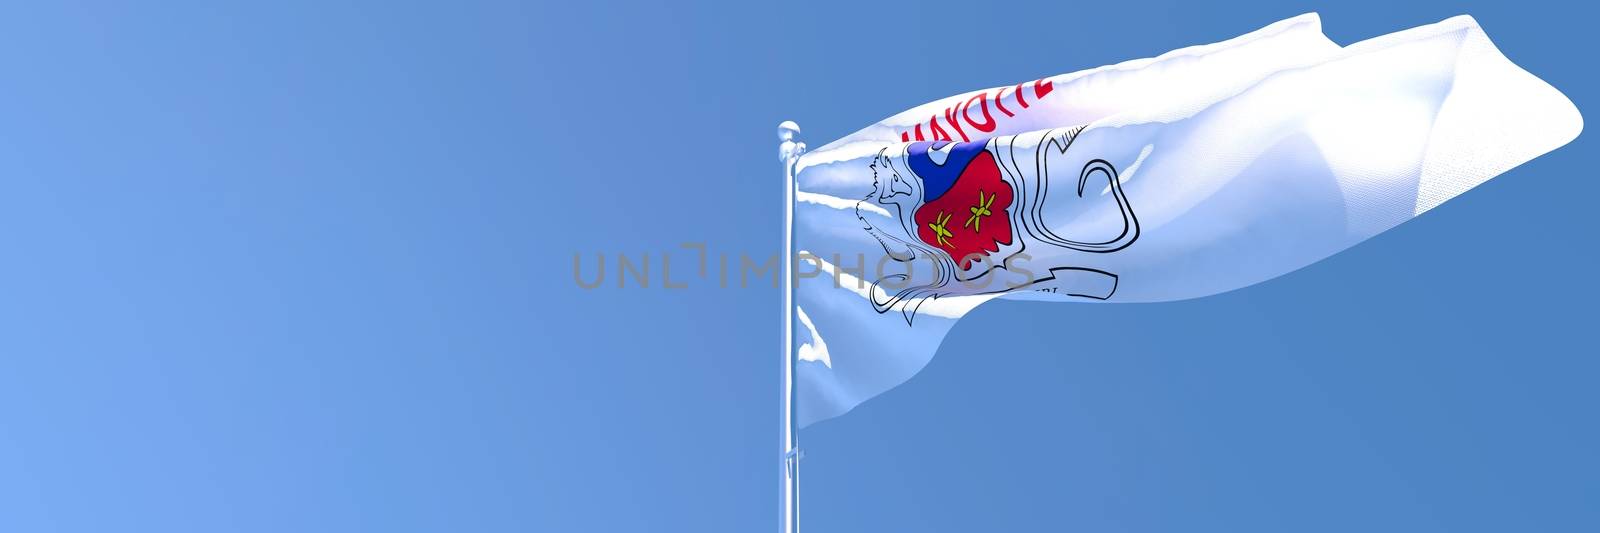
[778,120,805,533]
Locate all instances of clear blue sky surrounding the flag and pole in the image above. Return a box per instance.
[0,2,1600,533]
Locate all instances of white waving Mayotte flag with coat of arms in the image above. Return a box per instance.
[790,14,1582,426]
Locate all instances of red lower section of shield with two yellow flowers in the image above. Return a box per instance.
[914,150,1013,269]
